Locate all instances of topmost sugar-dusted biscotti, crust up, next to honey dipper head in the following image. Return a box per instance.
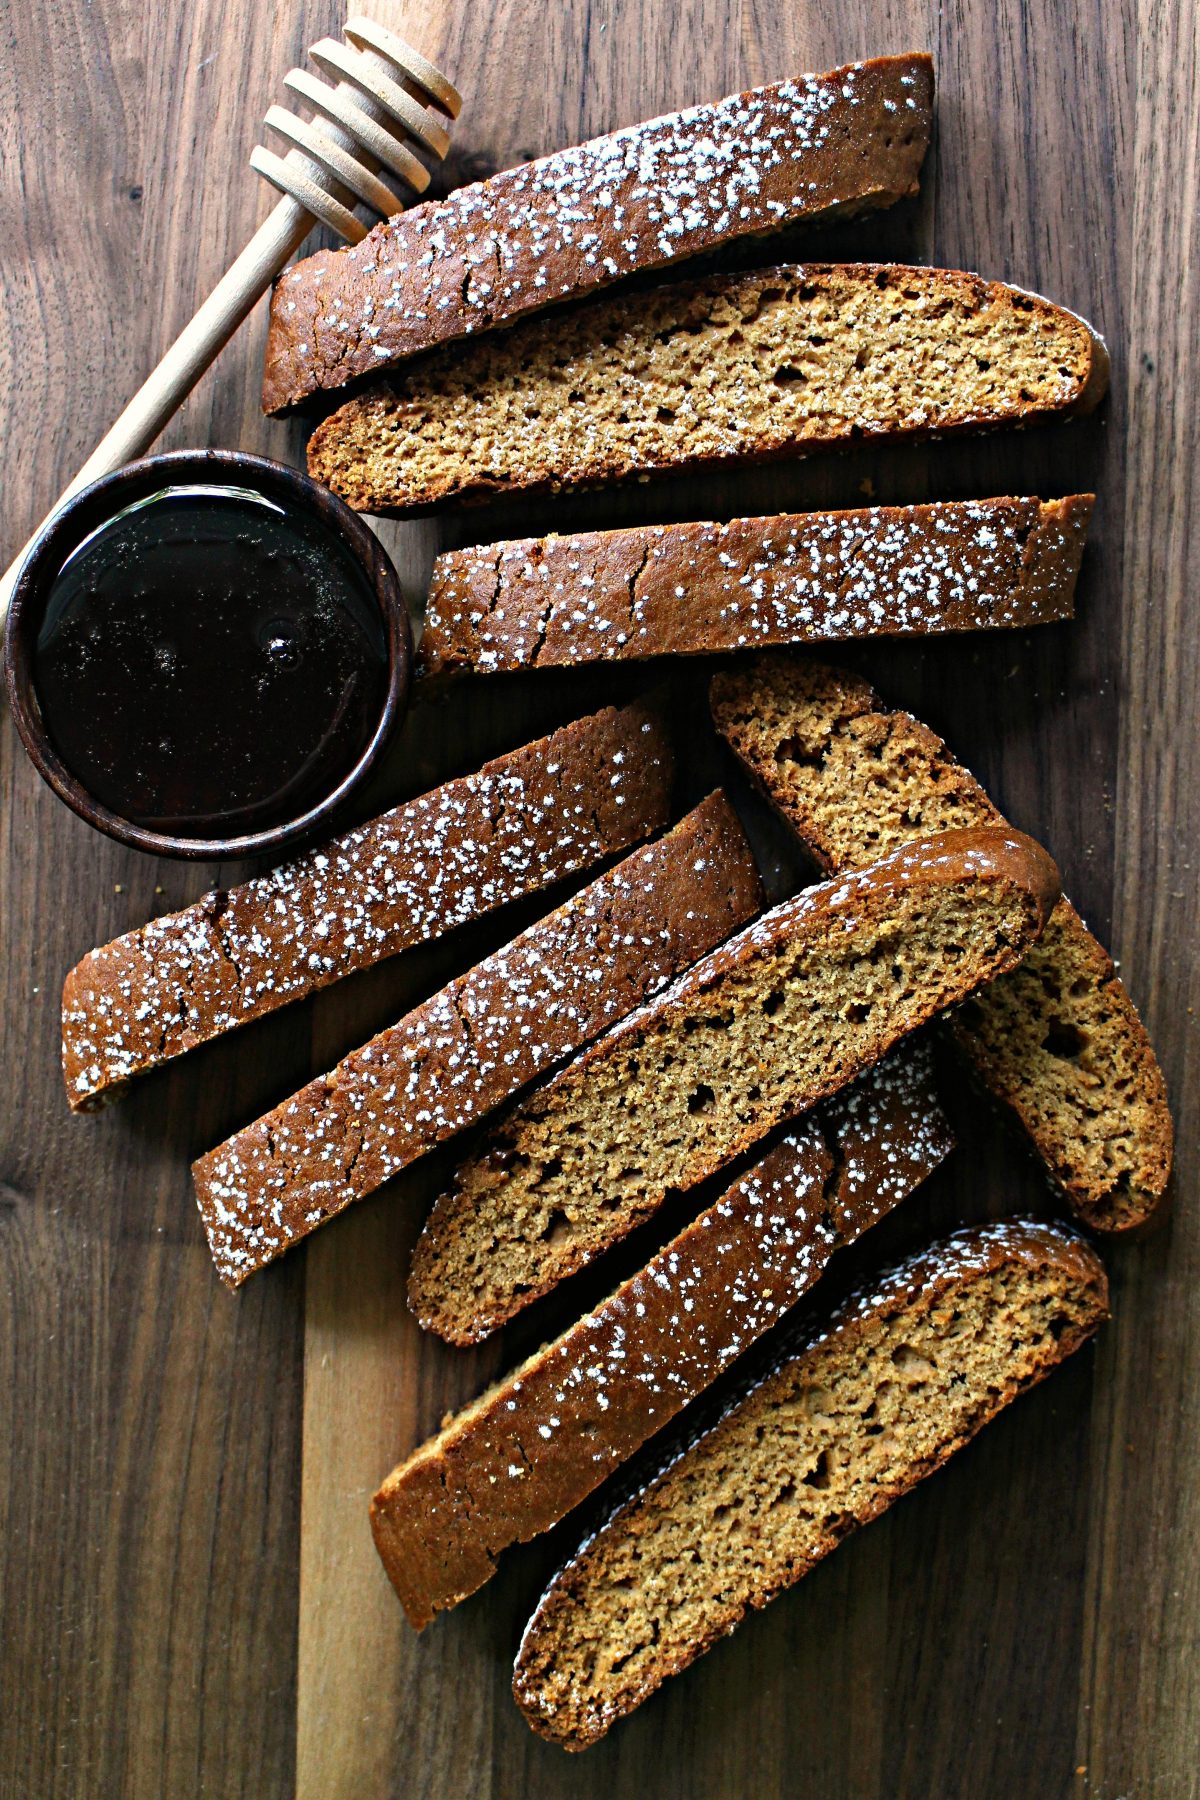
[263,56,934,412]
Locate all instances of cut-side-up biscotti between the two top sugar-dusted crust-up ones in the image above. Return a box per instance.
[308,263,1108,513]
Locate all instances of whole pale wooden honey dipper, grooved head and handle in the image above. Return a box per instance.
[0,18,462,621]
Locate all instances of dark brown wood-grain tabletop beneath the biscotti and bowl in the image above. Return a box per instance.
[0,0,1200,1800]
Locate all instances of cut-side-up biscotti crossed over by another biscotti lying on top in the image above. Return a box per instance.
[712,655,1173,1231]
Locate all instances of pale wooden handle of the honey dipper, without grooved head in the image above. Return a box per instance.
[0,196,313,623]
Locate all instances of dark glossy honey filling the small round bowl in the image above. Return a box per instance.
[32,484,389,839]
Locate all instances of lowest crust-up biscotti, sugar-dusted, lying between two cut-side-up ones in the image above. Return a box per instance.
[371,1051,952,1629]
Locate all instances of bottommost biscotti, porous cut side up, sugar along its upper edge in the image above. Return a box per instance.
[513,1220,1108,1750]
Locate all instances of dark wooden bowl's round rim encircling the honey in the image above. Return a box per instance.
[4,450,412,860]
